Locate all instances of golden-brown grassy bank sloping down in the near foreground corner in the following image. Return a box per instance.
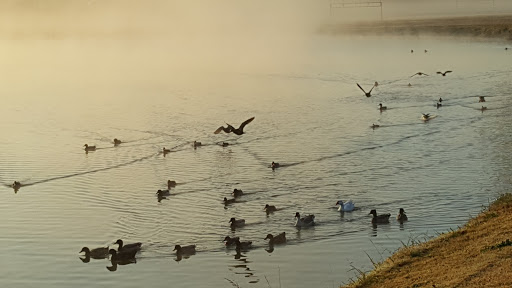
[346,194,512,288]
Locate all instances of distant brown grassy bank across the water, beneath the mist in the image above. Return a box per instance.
[320,16,512,41]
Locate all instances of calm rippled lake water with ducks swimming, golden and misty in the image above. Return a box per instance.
[0,28,512,287]
